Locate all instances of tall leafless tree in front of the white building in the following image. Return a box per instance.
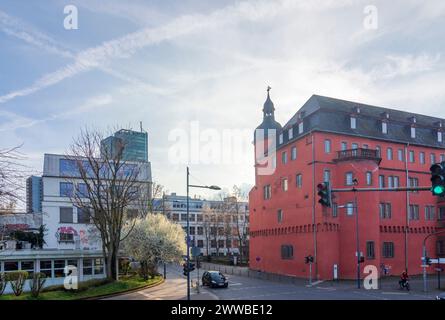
[66,129,150,279]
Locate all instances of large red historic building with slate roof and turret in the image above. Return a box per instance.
[249,93,445,279]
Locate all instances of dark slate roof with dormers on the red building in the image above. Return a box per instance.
[282,95,445,148]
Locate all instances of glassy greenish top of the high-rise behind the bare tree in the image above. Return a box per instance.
[101,129,148,162]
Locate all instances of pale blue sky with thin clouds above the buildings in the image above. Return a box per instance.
[0,0,445,202]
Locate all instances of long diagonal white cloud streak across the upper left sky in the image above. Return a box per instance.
[0,0,332,103]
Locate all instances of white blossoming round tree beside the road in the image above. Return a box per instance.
[122,214,187,279]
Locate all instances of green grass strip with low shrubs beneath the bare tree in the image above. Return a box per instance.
[0,276,162,300]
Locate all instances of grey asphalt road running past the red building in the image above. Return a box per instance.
[105,266,437,300]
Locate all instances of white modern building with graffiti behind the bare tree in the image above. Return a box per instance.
[0,154,151,293]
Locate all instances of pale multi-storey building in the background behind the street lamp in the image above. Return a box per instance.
[156,193,249,257]
